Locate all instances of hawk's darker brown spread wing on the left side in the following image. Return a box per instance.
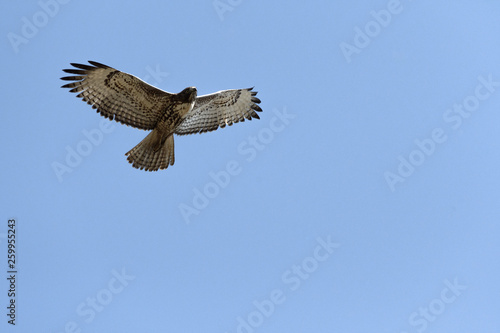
[61,61,172,130]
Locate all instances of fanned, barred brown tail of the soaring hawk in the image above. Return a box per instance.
[125,129,175,171]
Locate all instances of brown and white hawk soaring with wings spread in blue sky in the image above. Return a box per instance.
[61,61,262,171]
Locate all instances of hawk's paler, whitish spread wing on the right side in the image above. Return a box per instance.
[175,88,262,135]
